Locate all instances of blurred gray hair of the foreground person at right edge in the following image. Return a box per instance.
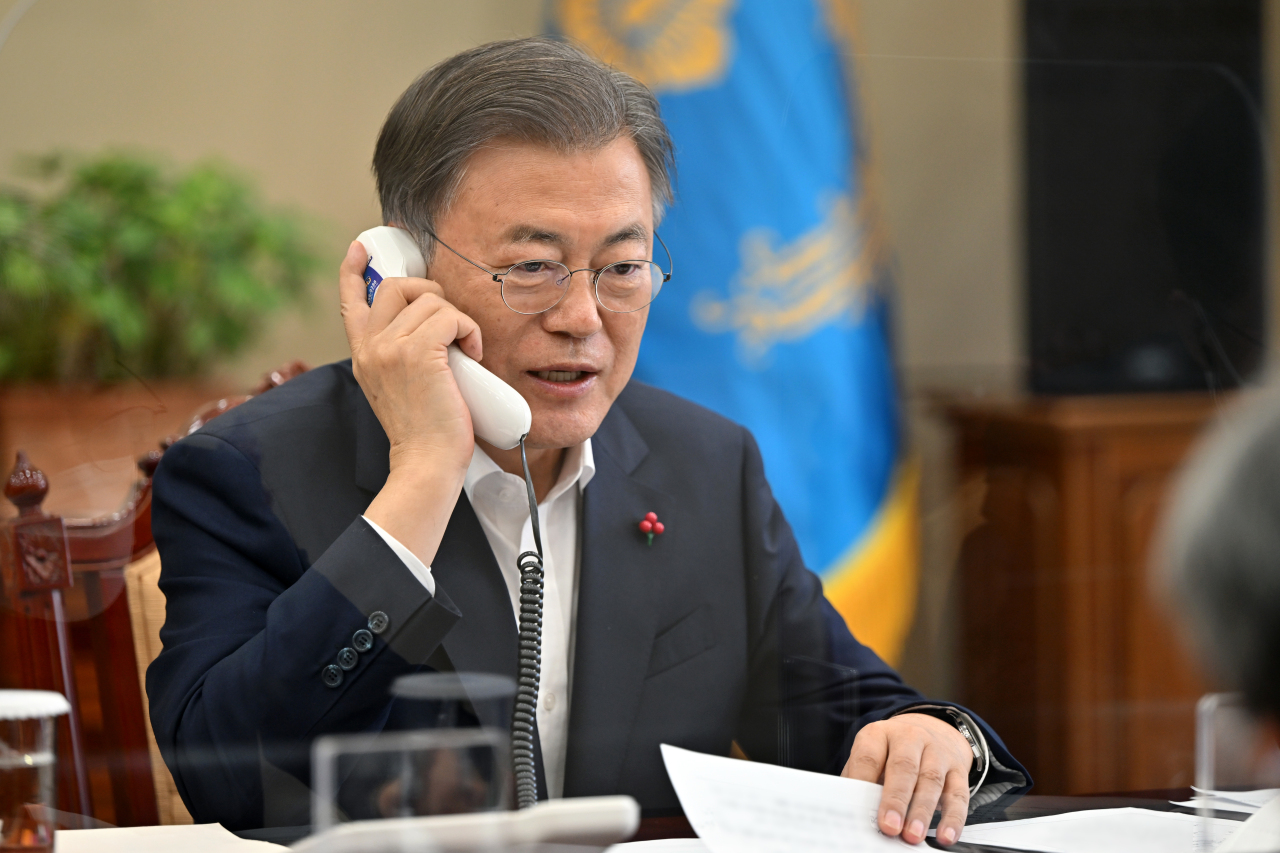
[1156,391,1280,719]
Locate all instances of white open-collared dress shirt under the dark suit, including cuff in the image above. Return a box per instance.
[365,438,595,798]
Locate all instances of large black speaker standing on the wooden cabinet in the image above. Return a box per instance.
[1023,0,1266,393]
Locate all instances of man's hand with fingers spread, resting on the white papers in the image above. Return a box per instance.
[840,712,973,844]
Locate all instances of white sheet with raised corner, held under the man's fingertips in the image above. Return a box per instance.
[662,744,920,853]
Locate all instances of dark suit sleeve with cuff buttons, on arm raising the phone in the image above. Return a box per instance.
[146,433,458,829]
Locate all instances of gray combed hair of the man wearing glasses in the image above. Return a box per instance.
[374,37,675,260]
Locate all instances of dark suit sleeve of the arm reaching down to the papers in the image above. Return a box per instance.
[739,433,1029,792]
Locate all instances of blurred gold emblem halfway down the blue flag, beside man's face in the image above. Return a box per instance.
[690,193,888,361]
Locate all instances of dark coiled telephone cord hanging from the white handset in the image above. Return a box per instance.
[511,437,543,808]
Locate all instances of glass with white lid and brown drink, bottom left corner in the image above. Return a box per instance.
[0,690,70,853]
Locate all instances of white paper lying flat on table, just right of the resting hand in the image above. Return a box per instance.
[960,808,1240,853]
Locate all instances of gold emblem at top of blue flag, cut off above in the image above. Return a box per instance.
[554,0,736,91]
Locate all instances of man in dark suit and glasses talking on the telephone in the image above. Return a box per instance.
[147,38,1028,843]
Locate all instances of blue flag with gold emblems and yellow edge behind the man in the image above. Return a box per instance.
[553,0,916,658]
